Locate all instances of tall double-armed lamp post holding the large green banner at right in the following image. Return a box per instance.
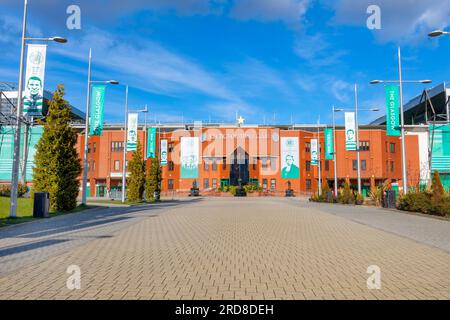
[370,47,432,194]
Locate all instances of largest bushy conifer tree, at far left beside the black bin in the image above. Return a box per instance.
[33,85,81,211]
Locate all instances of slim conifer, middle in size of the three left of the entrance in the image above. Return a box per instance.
[127,140,145,201]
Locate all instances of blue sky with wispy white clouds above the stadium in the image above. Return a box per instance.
[0,0,450,124]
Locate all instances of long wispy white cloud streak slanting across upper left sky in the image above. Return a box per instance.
[49,29,238,100]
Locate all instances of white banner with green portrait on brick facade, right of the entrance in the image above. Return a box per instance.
[281,137,300,179]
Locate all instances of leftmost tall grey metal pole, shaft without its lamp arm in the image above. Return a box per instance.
[9,0,28,218]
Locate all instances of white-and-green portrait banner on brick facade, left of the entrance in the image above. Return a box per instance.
[180,137,199,179]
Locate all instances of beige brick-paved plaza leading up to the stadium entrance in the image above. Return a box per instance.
[0,198,450,299]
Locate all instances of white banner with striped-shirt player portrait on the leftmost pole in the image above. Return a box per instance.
[23,44,47,117]
